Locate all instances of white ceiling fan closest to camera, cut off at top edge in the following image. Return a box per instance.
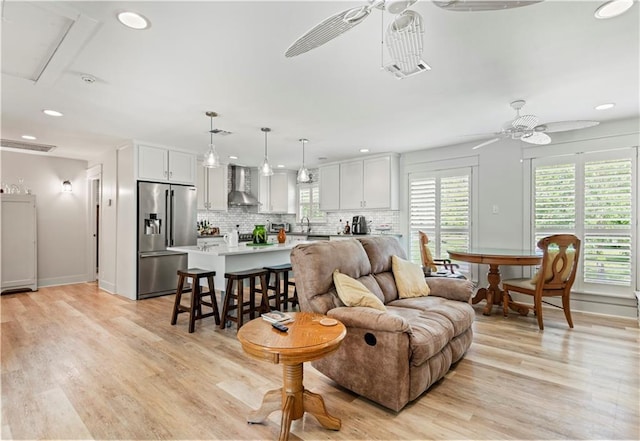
[285,0,542,78]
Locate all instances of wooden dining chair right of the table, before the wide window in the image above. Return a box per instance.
[502,234,580,330]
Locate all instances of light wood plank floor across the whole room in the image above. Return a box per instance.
[0,284,640,440]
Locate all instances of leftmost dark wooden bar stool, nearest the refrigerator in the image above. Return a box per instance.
[171,268,220,333]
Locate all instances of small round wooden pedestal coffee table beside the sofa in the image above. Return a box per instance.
[238,312,347,440]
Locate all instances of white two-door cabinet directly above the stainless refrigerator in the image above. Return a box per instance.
[137,144,196,185]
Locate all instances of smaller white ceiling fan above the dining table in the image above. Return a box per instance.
[473,100,600,150]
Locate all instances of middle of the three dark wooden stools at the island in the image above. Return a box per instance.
[220,268,270,329]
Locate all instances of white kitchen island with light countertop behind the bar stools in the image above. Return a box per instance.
[167,241,305,296]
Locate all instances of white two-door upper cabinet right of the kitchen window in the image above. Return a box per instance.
[338,155,400,210]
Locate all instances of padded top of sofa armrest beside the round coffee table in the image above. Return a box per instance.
[327,306,411,332]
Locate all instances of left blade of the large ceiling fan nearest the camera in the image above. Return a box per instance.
[285,5,371,58]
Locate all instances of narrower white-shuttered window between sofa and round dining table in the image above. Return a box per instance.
[409,168,471,272]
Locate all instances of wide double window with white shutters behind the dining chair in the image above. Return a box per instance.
[533,150,637,293]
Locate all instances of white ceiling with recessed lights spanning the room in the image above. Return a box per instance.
[2,0,640,168]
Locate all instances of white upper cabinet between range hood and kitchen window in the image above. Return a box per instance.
[251,169,296,214]
